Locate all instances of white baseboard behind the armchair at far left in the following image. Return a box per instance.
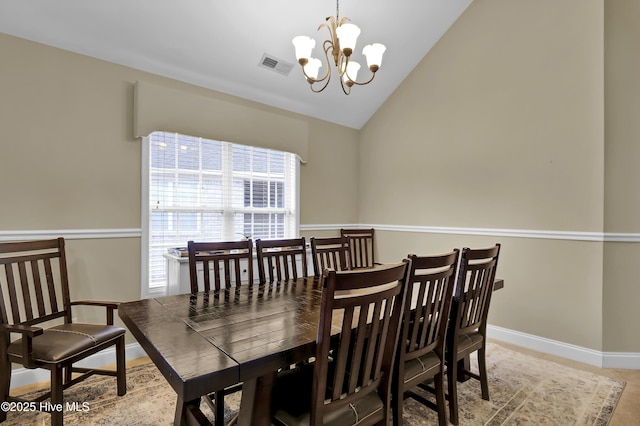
[11,343,147,389]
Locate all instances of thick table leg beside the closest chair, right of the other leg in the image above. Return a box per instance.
[238,372,277,426]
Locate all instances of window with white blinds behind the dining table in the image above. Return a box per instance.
[142,132,299,297]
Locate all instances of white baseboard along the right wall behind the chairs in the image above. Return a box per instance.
[487,325,640,370]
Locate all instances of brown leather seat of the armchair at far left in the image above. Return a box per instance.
[7,323,125,363]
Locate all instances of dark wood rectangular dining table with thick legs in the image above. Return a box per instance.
[118,277,504,426]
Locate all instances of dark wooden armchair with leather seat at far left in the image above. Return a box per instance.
[0,238,127,425]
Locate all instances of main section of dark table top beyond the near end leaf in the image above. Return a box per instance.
[156,277,322,381]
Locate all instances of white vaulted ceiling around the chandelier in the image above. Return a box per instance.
[0,0,472,129]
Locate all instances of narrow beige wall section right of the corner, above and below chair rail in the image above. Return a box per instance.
[603,0,640,352]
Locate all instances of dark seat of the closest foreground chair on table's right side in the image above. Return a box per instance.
[273,365,384,426]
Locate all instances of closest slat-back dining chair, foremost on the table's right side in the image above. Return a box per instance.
[271,260,410,426]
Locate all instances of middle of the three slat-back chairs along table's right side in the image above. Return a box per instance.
[392,249,459,426]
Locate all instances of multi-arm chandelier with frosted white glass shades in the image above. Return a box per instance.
[292,0,386,95]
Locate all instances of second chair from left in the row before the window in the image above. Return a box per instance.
[256,237,308,284]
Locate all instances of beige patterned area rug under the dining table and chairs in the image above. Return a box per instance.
[3,343,624,426]
